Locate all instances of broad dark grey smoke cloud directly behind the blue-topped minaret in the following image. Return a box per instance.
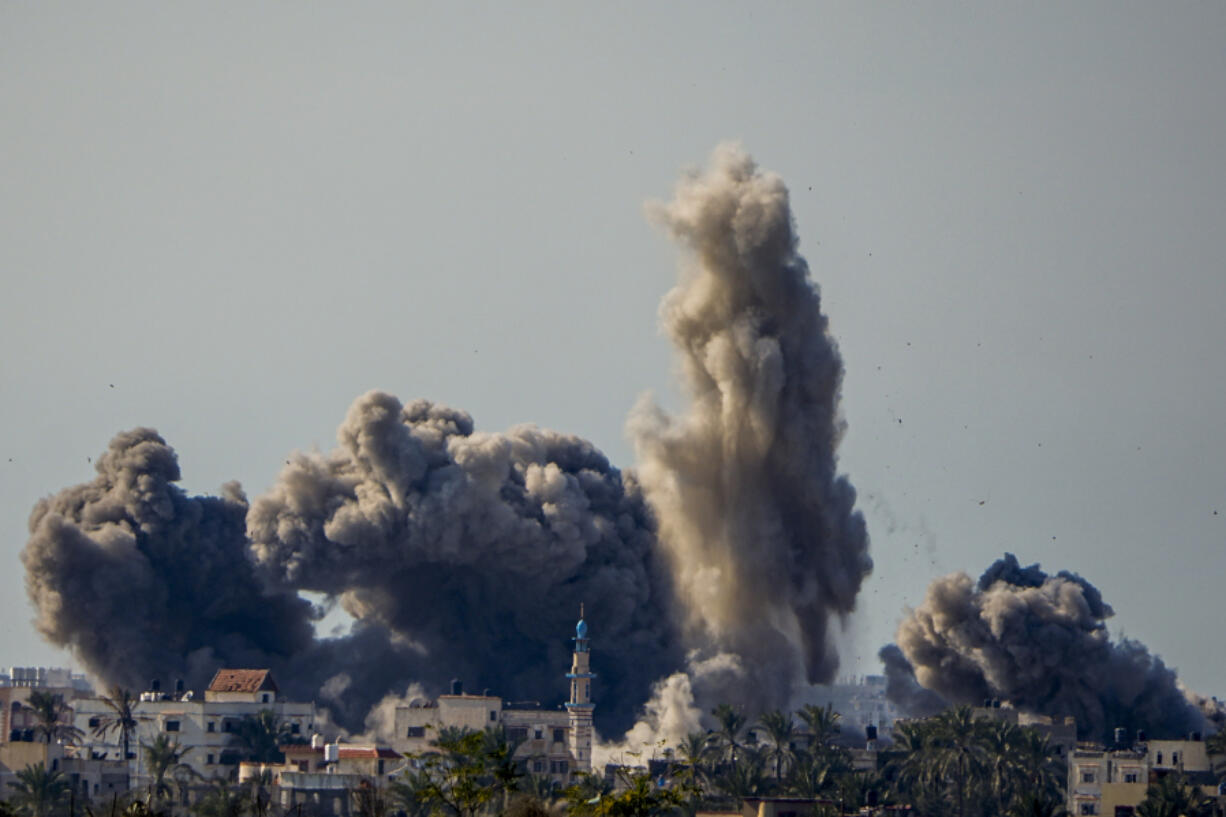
[248,391,682,729]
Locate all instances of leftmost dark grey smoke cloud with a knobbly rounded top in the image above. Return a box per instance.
[21,428,313,689]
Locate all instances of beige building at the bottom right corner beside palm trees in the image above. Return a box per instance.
[1065,730,1217,817]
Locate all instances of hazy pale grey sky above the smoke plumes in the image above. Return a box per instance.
[0,2,1226,694]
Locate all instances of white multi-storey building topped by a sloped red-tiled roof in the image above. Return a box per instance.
[74,670,315,786]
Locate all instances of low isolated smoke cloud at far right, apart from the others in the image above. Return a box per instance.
[883,553,1205,738]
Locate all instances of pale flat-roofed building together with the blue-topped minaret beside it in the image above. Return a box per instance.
[391,612,596,785]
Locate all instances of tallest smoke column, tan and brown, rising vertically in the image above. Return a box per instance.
[630,146,872,709]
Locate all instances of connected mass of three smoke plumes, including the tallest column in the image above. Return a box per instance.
[22,147,872,735]
